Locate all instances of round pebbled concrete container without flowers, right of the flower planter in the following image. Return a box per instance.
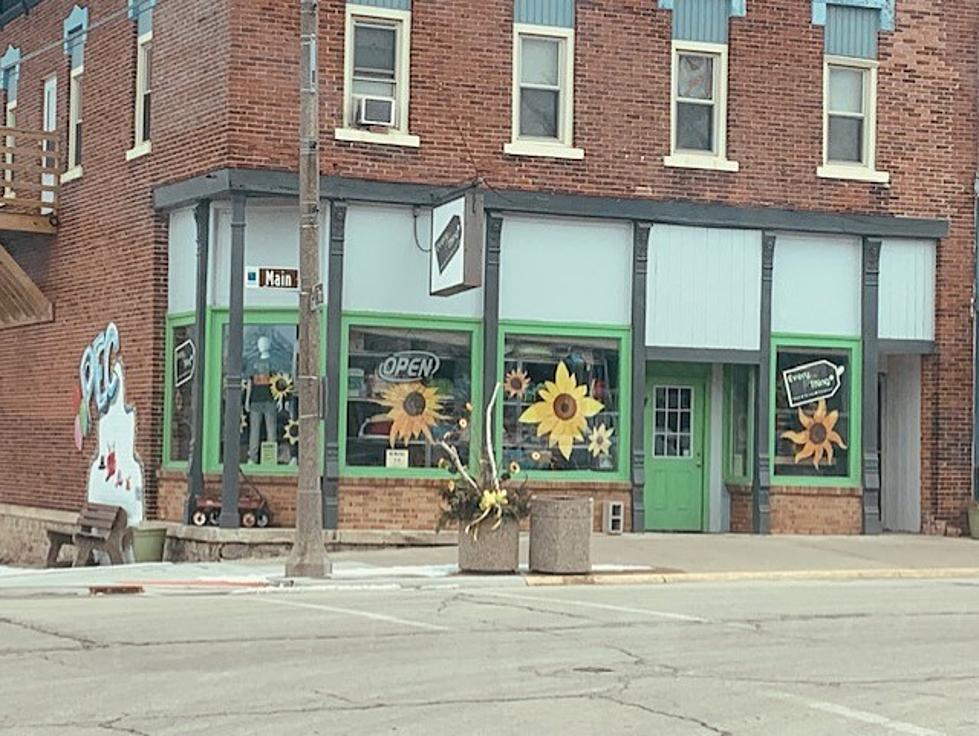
[530,496,594,575]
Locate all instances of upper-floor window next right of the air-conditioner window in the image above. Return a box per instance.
[504,23,584,159]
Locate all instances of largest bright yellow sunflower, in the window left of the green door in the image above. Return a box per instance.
[520,361,605,460]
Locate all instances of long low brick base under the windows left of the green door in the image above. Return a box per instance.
[158,472,632,532]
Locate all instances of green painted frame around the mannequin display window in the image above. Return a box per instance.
[204,307,302,477]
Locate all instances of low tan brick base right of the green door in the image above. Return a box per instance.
[728,486,863,534]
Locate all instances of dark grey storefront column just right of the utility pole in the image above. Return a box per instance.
[323,202,347,529]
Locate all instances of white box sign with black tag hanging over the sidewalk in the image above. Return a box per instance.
[429,190,486,296]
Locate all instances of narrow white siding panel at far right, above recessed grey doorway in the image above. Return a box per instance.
[878,239,936,340]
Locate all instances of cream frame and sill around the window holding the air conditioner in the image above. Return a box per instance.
[333,3,421,148]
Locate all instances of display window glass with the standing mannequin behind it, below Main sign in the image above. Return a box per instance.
[220,324,299,467]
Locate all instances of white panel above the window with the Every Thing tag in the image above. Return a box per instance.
[772,234,862,337]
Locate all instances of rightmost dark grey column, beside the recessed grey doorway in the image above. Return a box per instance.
[853,238,883,534]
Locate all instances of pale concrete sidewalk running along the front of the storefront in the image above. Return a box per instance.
[0,534,979,596]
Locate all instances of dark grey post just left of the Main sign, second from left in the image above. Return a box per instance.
[220,194,245,529]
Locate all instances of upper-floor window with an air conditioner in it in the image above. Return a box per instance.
[335,4,419,147]
